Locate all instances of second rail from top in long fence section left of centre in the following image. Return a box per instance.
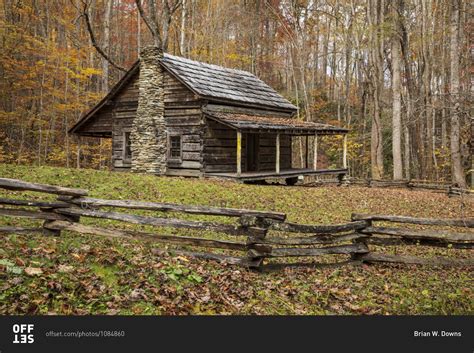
[55,208,261,235]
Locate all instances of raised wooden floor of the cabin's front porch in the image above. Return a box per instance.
[204,168,348,181]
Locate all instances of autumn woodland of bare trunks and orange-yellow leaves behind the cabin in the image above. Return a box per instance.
[0,0,473,182]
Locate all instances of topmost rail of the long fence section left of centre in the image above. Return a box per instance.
[59,197,286,221]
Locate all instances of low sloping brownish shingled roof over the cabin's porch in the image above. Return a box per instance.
[205,111,349,135]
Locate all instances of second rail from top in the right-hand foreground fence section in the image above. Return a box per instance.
[360,227,474,242]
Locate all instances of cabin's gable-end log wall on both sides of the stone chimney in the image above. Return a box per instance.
[113,73,202,176]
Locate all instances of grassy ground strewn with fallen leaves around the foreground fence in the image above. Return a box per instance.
[0,164,474,315]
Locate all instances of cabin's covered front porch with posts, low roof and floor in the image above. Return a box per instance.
[204,112,349,184]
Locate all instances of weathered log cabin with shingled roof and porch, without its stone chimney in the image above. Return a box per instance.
[69,54,348,184]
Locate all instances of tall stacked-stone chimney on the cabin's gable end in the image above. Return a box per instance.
[130,46,167,174]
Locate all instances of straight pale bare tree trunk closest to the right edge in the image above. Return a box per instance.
[450,0,466,187]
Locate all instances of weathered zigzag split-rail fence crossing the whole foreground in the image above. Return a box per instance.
[0,178,474,268]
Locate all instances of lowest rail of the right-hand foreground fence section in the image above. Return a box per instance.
[356,252,474,267]
